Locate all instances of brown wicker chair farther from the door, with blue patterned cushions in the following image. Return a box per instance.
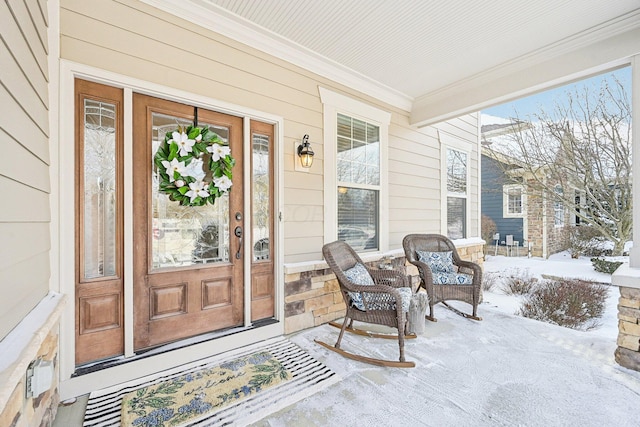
[402,234,482,322]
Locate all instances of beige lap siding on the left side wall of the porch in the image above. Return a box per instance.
[0,0,50,339]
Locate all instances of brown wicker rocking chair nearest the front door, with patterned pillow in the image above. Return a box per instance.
[316,241,416,368]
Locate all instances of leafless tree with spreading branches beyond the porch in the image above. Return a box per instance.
[488,76,632,255]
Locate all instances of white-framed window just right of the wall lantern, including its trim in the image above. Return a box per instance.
[320,88,391,251]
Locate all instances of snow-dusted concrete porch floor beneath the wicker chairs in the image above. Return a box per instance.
[54,304,640,427]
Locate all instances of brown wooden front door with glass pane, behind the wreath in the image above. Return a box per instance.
[133,94,246,351]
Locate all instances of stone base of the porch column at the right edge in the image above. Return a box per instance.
[615,286,640,371]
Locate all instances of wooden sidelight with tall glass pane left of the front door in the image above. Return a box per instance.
[75,80,124,365]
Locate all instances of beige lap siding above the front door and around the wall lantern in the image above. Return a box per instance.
[60,0,480,262]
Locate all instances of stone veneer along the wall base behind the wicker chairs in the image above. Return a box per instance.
[284,242,484,334]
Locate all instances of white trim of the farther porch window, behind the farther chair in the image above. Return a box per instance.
[438,143,471,239]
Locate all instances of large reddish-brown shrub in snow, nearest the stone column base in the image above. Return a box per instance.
[518,279,609,330]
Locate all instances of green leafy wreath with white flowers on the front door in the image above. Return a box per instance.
[153,126,236,206]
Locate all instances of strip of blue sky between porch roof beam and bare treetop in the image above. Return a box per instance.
[482,67,631,118]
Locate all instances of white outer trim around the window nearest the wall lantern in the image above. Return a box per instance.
[318,87,391,253]
